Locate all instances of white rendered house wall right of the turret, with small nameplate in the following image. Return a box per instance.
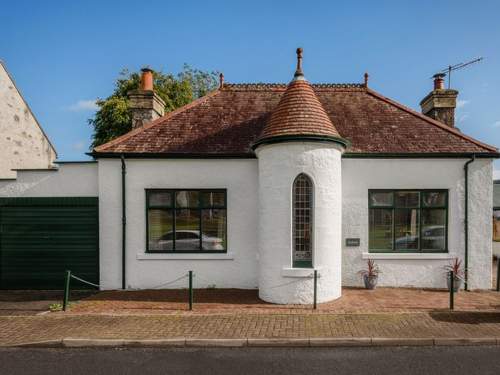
[342,158,493,289]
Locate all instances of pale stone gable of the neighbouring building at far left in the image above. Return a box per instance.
[0,61,57,179]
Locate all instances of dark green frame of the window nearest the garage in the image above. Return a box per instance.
[144,188,229,254]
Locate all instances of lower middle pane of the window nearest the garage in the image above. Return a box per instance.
[175,209,200,250]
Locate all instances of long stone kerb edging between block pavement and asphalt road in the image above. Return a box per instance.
[6,337,500,348]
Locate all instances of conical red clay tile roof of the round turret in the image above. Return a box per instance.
[257,77,340,143]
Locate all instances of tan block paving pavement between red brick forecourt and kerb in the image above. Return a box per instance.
[0,312,500,345]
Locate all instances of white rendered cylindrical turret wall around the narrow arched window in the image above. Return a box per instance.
[256,142,342,304]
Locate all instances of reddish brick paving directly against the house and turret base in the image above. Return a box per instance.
[66,288,500,315]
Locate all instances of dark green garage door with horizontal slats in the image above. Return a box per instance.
[0,197,99,289]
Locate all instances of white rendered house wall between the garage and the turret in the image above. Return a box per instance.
[99,159,258,289]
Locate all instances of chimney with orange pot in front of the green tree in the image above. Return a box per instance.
[127,68,165,129]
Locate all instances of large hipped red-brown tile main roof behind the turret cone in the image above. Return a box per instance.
[94,84,497,157]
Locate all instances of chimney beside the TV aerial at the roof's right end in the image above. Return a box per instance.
[420,73,458,127]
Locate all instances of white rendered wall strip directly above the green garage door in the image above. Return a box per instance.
[0,162,98,197]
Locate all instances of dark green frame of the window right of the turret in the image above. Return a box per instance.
[368,189,450,254]
